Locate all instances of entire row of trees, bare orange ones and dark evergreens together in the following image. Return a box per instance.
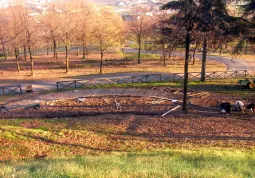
[0,0,254,111]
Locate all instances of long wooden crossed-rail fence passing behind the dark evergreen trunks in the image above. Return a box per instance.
[56,70,255,90]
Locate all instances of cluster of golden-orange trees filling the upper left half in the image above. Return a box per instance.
[0,0,124,75]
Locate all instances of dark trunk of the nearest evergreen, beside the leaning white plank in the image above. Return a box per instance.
[182,32,190,113]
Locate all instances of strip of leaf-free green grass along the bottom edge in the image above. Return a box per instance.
[0,150,255,178]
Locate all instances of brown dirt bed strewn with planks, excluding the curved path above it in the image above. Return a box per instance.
[0,93,254,119]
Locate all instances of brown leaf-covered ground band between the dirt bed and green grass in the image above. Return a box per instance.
[0,114,255,161]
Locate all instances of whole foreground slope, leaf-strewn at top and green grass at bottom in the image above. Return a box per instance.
[0,115,255,178]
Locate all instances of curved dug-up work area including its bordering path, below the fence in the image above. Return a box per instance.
[0,87,254,119]
